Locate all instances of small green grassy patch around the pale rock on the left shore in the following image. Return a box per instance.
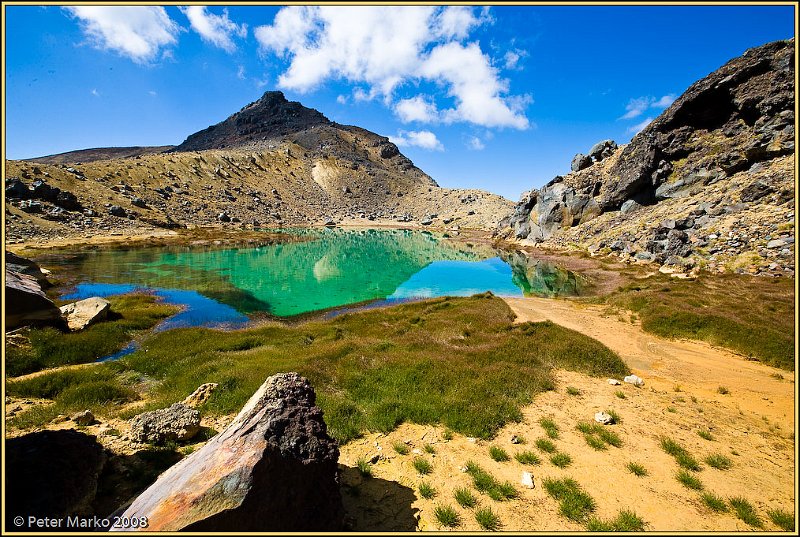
[6,294,179,377]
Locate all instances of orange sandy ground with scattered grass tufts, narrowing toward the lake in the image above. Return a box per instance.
[340,298,795,531]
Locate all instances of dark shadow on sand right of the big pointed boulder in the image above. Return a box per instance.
[339,464,418,532]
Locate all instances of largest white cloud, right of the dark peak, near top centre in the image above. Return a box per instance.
[254,6,528,129]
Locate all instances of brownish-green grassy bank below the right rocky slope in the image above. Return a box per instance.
[600,274,795,371]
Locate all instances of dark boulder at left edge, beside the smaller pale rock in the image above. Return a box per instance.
[5,266,64,330]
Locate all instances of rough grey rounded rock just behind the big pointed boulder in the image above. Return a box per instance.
[130,403,200,444]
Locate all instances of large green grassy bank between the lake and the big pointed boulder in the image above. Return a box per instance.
[7,294,628,442]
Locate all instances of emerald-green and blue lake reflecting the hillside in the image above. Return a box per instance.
[50,229,580,329]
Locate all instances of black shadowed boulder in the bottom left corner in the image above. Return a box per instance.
[4,429,106,531]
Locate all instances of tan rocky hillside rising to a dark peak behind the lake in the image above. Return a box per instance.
[6,92,513,242]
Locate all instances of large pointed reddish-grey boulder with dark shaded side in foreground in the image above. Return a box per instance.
[115,373,344,532]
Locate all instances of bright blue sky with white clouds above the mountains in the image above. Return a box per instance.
[4,4,794,200]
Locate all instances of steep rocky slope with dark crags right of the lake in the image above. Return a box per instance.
[499,40,796,274]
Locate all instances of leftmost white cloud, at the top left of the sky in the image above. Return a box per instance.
[64,6,180,63]
